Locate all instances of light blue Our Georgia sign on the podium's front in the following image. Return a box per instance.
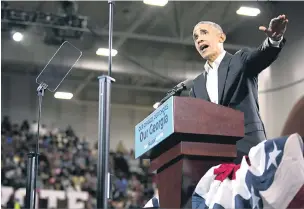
[135,97,174,158]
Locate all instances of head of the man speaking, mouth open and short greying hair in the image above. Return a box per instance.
[193,24,224,60]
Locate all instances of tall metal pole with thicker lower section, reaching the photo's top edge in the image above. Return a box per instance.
[96,0,115,209]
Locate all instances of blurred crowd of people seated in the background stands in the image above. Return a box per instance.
[1,117,156,208]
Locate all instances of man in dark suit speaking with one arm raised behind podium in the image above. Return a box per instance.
[190,15,288,163]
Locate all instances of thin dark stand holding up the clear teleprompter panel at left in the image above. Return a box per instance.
[25,83,48,209]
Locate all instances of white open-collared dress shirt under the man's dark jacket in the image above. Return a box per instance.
[204,37,283,104]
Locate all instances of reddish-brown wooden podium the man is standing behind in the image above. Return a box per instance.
[135,97,244,208]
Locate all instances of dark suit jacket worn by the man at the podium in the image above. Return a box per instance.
[190,39,286,148]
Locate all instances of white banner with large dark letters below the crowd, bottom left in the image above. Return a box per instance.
[1,187,89,209]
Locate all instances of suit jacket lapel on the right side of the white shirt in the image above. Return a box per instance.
[218,52,232,104]
